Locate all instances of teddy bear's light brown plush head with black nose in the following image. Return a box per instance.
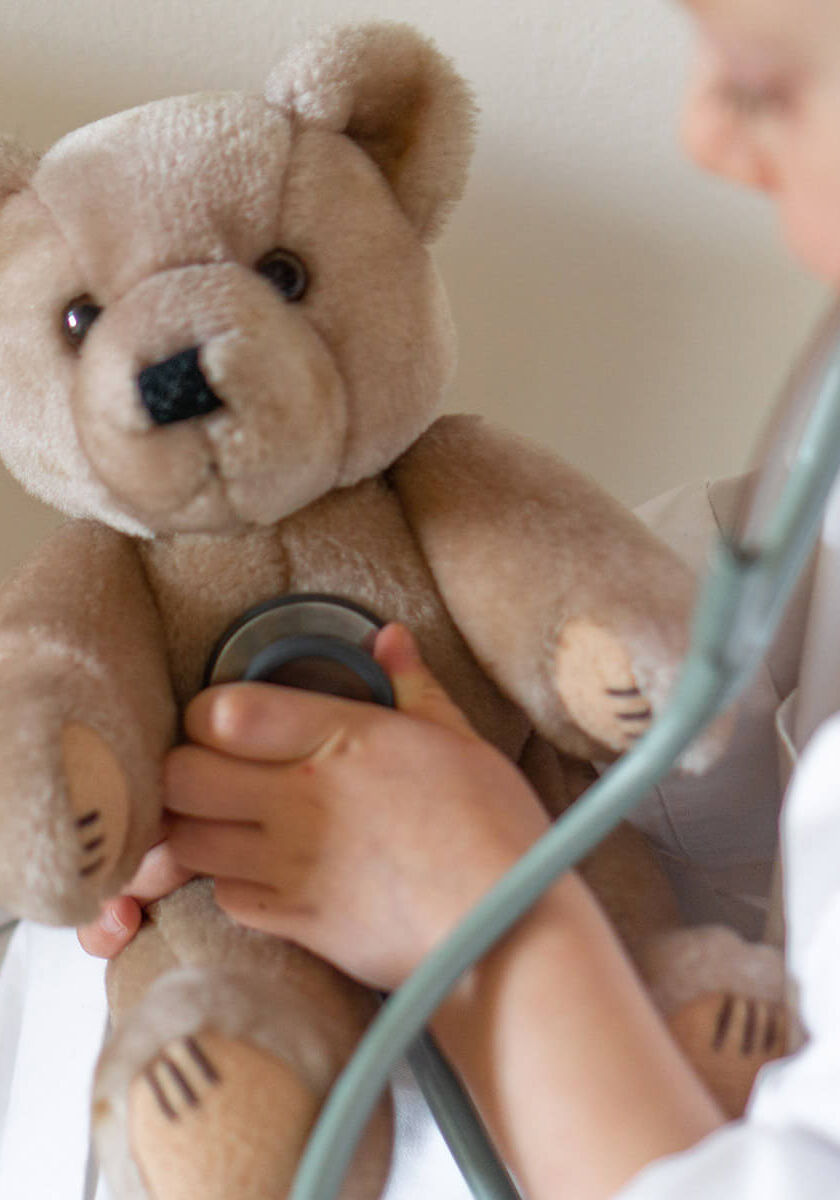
[0,24,473,535]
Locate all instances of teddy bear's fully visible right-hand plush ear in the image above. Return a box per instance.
[265,23,475,240]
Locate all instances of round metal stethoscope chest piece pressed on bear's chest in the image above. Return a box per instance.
[204,593,395,707]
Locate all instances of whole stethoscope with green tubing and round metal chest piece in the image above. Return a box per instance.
[208,305,840,1200]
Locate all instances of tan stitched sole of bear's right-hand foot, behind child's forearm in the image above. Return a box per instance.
[668,991,791,1117]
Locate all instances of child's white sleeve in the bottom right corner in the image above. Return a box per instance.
[619,716,840,1200]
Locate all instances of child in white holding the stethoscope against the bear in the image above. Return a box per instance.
[62,0,840,1200]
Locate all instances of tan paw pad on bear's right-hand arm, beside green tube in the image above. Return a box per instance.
[554,618,654,752]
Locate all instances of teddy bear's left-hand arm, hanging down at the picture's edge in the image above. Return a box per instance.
[0,521,175,924]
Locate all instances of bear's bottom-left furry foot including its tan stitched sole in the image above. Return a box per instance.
[94,962,391,1200]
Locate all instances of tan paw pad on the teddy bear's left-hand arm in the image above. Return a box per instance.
[61,722,128,886]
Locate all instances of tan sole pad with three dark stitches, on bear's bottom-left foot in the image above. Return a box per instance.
[128,1030,319,1200]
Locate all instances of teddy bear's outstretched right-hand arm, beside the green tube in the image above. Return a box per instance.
[390,416,716,767]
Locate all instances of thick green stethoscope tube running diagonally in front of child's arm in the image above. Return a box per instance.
[289,321,840,1200]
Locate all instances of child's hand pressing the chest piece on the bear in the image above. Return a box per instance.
[82,625,547,989]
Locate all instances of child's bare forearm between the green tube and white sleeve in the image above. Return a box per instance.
[432,875,722,1200]
